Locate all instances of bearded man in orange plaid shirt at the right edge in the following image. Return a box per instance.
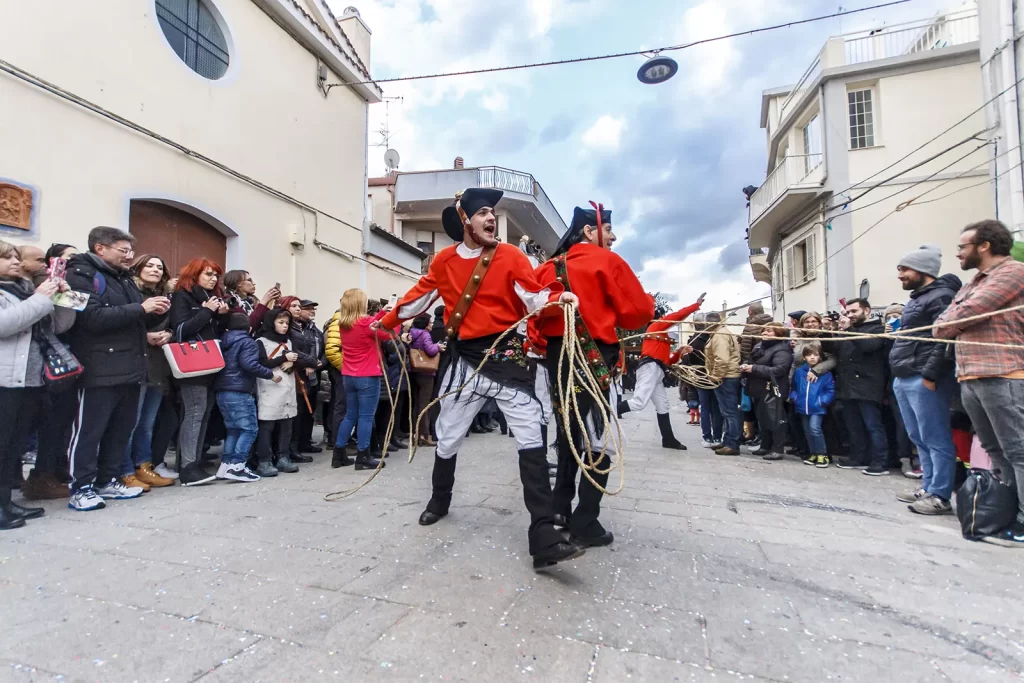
[932,220,1024,548]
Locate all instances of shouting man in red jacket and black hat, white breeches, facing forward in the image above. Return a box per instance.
[380,187,584,568]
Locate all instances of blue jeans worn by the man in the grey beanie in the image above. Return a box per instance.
[893,375,956,501]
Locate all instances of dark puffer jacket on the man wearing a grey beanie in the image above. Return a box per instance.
[889,273,964,382]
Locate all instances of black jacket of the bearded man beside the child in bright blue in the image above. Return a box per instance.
[828,319,888,403]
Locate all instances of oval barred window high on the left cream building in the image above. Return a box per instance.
[157,0,230,81]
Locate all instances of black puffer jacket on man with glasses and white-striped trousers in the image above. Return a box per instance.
[67,254,146,388]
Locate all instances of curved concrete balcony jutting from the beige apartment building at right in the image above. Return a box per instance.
[748,155,825,250]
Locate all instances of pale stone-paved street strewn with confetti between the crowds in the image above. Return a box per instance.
[0,405,1024,683]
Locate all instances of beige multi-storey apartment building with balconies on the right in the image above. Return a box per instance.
[748,3,997,319]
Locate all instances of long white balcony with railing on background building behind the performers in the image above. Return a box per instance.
[394,166,567,254]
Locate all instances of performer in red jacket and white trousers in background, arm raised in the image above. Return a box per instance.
[618,294,703,451]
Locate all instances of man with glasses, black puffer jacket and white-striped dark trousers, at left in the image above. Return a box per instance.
[67,226,171,511]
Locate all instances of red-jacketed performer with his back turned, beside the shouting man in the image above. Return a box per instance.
[530,205,654,547]
